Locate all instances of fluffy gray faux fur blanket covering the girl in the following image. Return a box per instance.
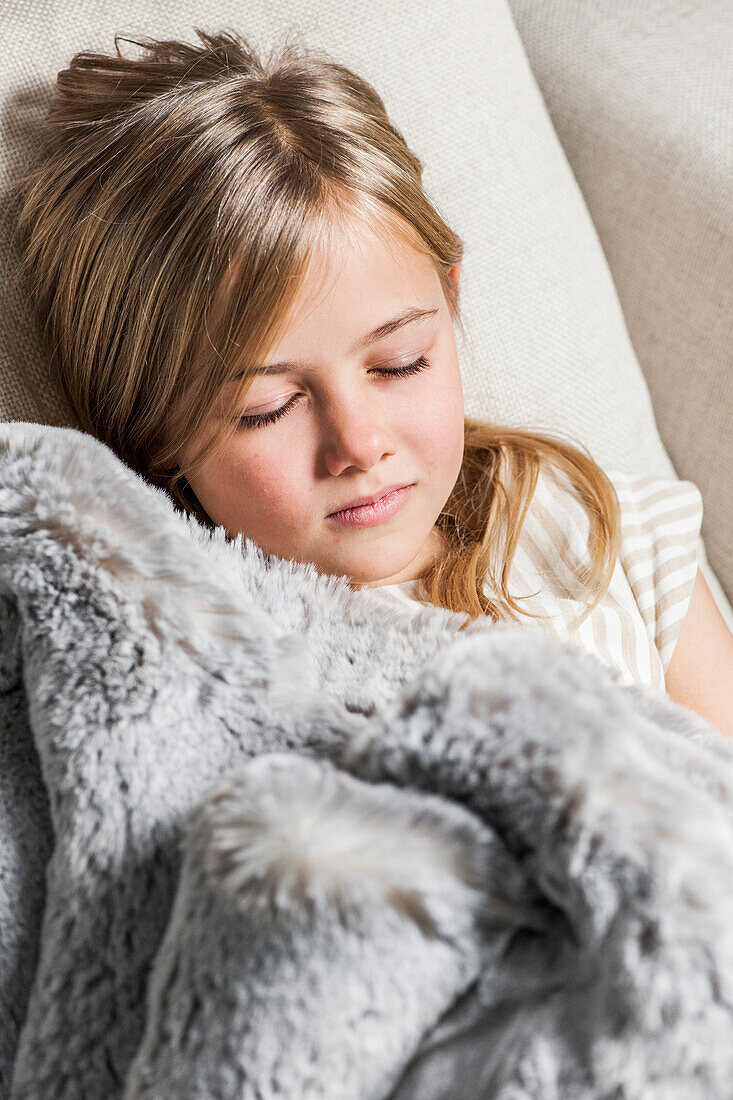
[0,422,733,1100]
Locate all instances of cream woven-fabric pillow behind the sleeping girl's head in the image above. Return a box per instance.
[0,0,726,629]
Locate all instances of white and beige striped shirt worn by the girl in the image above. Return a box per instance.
[373,468,702,691]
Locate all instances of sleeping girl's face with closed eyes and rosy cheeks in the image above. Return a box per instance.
[185,222,463,587]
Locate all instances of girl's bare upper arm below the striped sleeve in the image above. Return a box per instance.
[665,570,733,737]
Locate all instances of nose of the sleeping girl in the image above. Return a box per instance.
[322,394,395,476]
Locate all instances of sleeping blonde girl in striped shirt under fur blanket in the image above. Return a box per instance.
[17,30,733,732]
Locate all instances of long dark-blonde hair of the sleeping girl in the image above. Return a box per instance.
[17,29,620,625]
